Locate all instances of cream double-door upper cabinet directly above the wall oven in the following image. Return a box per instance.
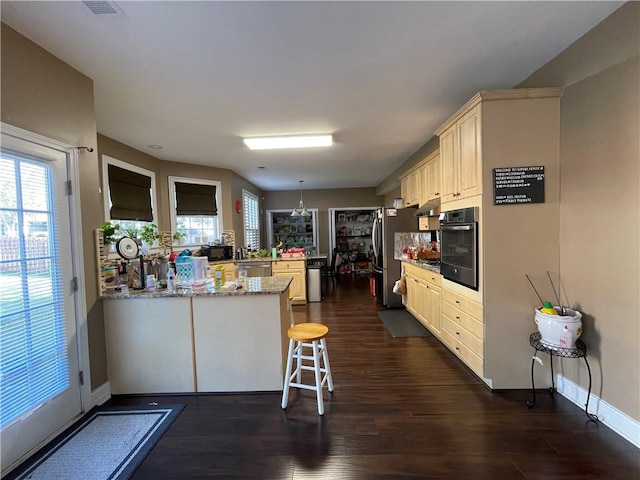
[435,105,482,203]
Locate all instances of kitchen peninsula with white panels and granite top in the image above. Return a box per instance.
[102,276,292,394]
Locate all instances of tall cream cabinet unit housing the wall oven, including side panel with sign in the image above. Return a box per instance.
[435,88,562,389]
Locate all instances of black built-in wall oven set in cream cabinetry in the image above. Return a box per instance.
[440,207,478,290]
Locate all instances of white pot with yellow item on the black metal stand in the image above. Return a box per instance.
[535,306,582,348]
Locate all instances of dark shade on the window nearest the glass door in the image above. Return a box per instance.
[108,165,153,222]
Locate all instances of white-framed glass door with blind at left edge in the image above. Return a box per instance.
[0,127,82,471]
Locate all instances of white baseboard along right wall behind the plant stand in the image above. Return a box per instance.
[556,375,640,448]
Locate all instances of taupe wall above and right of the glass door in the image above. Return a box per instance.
[0,23,107,387]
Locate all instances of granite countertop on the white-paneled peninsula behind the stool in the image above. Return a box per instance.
[100,276,293,300]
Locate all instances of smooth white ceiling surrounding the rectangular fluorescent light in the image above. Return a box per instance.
[1,0,623,190]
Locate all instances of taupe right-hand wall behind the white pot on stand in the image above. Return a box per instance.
[520,2,640,421]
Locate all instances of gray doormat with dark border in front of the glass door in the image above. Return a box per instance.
[8,405,184,480]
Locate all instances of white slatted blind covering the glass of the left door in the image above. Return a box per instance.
[0,152,69,428]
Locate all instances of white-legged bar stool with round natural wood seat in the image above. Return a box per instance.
[282,323,333,415]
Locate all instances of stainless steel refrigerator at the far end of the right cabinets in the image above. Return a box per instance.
[371,208,418,308]
